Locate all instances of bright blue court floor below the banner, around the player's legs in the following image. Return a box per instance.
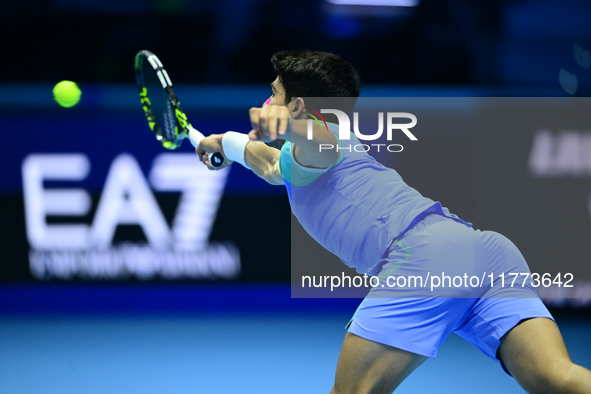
[0,304,591,394]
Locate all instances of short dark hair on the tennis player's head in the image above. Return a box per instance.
[271,50,361,113]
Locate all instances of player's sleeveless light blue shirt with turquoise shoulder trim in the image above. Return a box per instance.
[279,124,471,275]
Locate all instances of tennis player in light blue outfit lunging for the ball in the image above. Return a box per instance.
[196,51,591,394]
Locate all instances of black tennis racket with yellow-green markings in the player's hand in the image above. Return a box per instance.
[135,50,224,167]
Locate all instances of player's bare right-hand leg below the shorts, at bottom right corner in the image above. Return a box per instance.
[498,318,591,394]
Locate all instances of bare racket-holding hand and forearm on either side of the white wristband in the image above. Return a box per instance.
[195,134,283,185]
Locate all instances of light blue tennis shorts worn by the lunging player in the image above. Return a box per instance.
[348,214,553,370]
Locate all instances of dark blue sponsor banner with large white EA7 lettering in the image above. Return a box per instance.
[0,85,289,281]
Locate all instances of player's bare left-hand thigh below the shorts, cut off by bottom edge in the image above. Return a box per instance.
[331,332,427,394]
